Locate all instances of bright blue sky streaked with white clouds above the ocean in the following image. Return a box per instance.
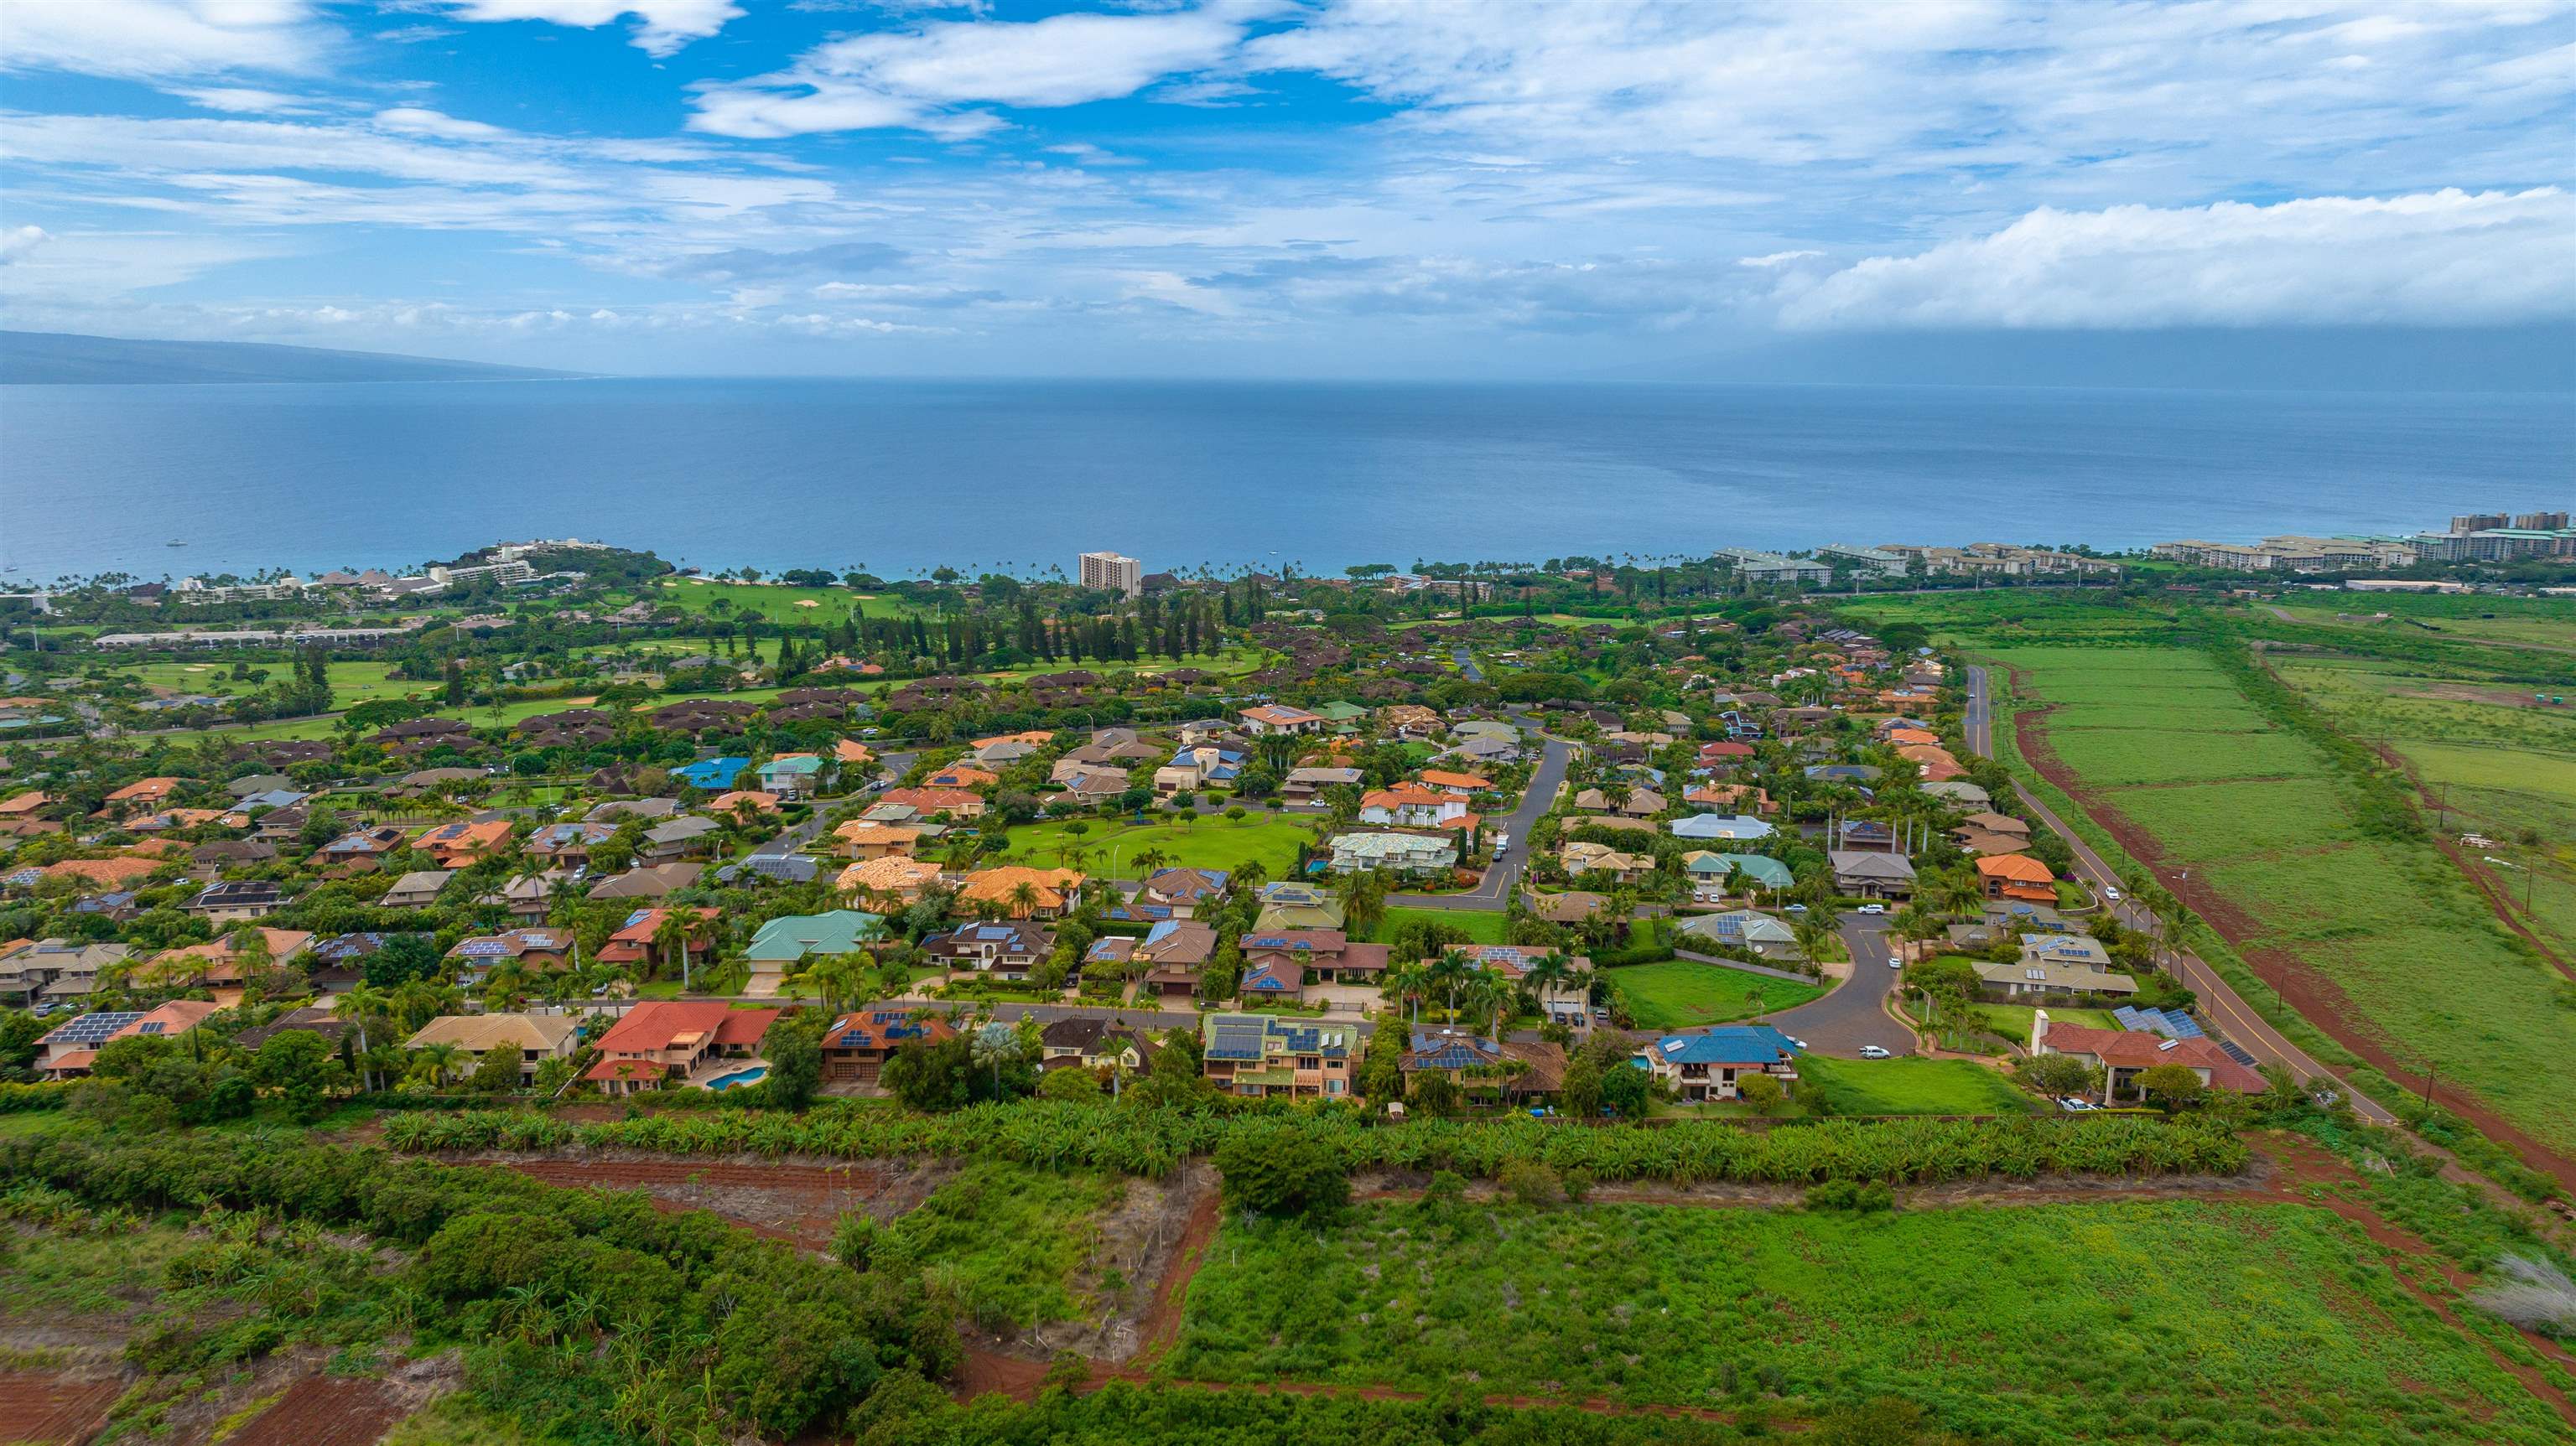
[0,0,2576,376]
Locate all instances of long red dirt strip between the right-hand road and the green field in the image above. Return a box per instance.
[2012,669,2576,1194]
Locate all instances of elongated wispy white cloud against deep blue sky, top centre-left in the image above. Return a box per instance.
[690,8,1244,137]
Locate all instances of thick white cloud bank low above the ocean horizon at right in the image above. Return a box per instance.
[1780,188,2576,329]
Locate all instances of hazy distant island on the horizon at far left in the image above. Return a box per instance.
[0,332,574,386]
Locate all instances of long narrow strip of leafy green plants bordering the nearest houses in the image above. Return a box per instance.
[387,1101,2246,1184]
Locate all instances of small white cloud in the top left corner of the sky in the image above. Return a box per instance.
[0,0,327,77]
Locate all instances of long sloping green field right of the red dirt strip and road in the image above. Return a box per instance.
[1994,638,2576,1153]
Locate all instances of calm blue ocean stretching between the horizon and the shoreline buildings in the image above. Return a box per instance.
[0,378,2576,582]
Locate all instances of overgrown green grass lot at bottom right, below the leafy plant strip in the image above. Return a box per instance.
[1170,1201,2566,1446]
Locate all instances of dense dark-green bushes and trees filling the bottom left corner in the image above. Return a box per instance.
[0,1132,958,1441]
